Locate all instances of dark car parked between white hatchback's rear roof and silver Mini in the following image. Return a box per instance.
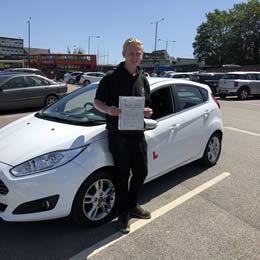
[194,72,225,95]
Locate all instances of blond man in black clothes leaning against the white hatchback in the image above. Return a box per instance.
[94,38,152,232]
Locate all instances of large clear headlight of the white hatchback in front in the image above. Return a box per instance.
[10,146,87,177]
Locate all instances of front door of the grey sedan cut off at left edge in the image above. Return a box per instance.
[0,76,27,109]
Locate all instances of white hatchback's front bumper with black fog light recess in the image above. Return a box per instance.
[0,161,86,221]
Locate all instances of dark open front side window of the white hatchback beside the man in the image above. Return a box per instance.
[150,87,174,119]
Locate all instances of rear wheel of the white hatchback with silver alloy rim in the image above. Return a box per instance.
[201,133,222,167]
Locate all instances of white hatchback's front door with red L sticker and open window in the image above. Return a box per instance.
[145,86,184,179]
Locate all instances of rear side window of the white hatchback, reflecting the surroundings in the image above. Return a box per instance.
[174,85,205,110]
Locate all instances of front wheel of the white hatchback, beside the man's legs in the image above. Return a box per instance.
[71,170,116,227]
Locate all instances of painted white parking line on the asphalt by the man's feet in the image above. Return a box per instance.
[69,172,230,260]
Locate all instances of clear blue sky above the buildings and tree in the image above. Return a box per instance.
[0,0,247,64]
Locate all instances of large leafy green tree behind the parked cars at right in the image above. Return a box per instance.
[193,0,260,65]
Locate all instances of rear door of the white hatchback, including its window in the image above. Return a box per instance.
[173,84,211,161]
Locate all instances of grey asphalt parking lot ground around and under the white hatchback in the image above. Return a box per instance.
[0,86,260,260]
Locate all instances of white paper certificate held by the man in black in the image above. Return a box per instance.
[118,96,145,130]
